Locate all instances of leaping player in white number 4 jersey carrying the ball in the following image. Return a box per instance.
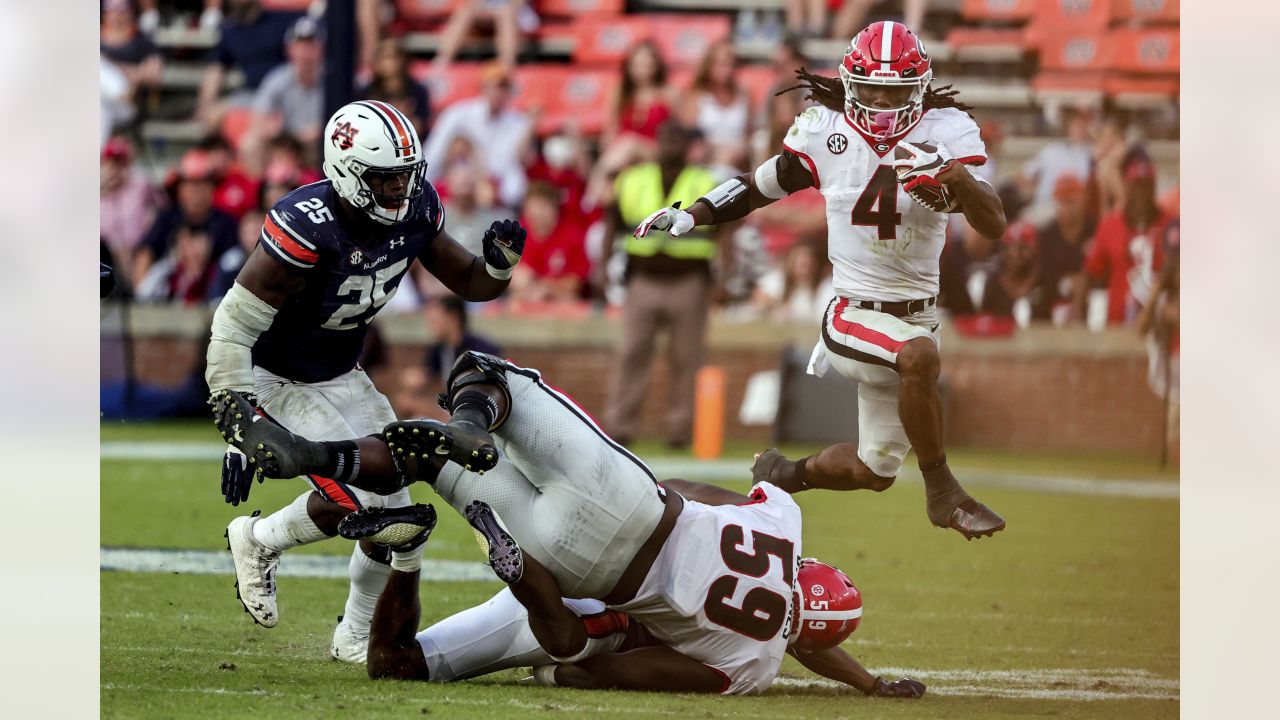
[635,22,1005,539]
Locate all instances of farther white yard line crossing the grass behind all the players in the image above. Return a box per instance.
[100,441,1179,500]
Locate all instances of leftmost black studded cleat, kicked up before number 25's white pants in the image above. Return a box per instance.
[210,389,326,478]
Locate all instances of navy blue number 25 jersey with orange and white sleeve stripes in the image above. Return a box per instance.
[253,181,444,383]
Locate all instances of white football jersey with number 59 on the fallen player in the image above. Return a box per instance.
[616,483,800,694]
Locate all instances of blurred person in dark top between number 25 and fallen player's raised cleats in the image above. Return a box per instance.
[396,293,502,420]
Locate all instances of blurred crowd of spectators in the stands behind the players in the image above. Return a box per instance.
[101,0,1178,334]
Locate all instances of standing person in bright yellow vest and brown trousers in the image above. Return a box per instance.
[603,120,732,448]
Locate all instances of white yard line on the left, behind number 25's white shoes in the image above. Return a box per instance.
[99,547,498,582]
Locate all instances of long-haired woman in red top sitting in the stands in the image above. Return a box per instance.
[586,41,675,208]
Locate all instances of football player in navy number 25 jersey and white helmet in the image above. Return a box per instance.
[205,100,525,664]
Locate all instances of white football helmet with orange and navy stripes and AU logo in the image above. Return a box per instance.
[324,100,426,225]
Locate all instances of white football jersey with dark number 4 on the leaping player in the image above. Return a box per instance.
[782,106,987,300]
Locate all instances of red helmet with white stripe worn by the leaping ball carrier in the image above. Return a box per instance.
[840,20,933,141]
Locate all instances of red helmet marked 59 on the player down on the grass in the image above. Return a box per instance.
[791,557,863,652]
